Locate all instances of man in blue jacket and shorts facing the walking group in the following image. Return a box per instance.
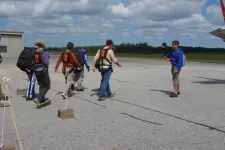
[162,40,183,97]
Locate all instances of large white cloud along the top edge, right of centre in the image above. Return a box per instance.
[107,0,206,21]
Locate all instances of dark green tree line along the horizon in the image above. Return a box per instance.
[28,42,225,54]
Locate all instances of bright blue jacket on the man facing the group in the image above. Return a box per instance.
[163,48,183,69]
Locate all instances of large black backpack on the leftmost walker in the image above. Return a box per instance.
[16,48,35,71]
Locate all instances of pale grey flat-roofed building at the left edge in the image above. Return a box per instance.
[0,31,24,57]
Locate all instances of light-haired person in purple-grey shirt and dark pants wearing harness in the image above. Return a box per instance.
[33,40,51,104]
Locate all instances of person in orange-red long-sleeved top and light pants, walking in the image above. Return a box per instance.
[55,42,82,99]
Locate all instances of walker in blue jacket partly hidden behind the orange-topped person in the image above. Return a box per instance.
[74,48,90,91]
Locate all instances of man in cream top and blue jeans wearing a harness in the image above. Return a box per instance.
[93,40,121,101]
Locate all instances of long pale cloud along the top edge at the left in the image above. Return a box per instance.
[0,0,106,18]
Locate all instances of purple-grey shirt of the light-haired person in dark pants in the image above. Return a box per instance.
[36,49,49,71]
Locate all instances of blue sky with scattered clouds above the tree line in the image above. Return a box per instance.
[0,0,225,47]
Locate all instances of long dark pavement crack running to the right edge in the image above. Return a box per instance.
[111,98,225,133]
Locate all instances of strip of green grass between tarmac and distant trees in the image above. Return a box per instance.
[49,53,225,63]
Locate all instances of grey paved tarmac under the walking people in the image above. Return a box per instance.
[0,57,225,150]
